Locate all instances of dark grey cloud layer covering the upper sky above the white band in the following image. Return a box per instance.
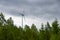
[0,0,60,18]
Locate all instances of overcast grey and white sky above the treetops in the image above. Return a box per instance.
[0,0,60,28]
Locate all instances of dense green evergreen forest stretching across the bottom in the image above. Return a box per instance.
[0,13,60,40]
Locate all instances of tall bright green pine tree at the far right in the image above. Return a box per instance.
[50,19,59,40]
